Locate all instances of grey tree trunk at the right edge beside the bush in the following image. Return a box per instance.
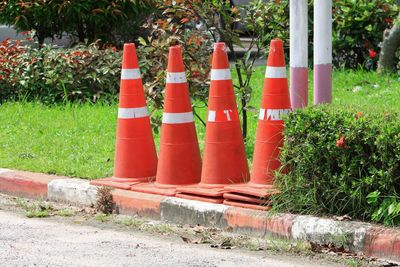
[378,13,400,72]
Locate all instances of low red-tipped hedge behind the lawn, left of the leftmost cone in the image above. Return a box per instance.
[0,40,121,104]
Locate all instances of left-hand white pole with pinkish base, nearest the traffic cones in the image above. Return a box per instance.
[290,0,308,109]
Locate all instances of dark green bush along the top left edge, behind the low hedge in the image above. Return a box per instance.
[0,0,154,44]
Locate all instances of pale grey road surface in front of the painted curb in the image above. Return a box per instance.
[0,210,348,267]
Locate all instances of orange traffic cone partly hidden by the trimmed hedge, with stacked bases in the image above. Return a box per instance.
[224,39,291,210]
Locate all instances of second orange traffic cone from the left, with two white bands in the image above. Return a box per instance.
[131,46,201,196]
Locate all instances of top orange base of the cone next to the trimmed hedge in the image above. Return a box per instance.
[224,183,279,198]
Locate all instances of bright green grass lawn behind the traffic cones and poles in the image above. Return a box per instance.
[0,68,400,179]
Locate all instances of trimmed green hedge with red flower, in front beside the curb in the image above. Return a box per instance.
[274,107,400,225]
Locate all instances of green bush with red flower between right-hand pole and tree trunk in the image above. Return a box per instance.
[333,0,398,69]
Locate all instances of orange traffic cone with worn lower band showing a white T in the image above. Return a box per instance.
[177,43,249,203]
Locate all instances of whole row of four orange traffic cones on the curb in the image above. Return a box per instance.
[92,40,290,209]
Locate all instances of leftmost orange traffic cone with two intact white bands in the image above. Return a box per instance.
[91,44,157,189]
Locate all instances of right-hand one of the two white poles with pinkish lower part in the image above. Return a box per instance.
[314,0,332,105]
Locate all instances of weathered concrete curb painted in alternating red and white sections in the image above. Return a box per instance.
[0,169,400,262]
